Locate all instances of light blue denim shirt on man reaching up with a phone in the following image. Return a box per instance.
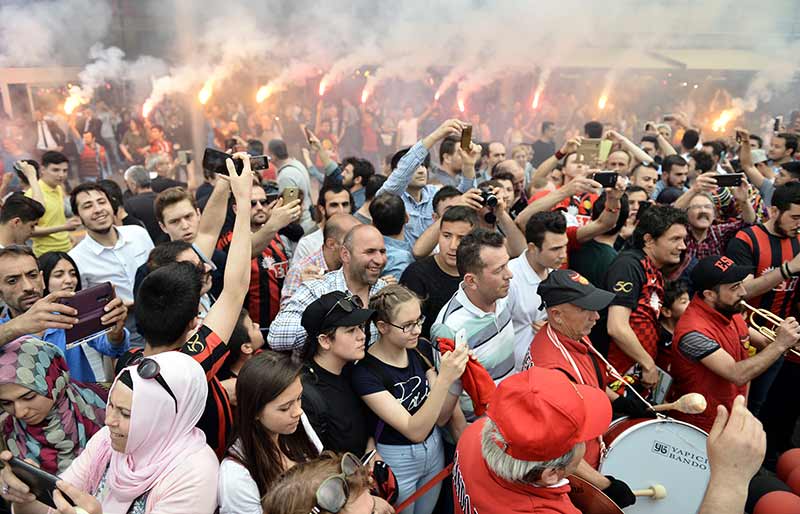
[375,141,475,246]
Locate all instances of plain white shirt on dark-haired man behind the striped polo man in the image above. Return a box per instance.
[508,250,549,371]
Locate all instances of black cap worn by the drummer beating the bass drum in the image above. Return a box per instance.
[539,269,615,311]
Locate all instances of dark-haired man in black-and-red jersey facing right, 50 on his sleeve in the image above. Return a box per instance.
[605,205,687,388]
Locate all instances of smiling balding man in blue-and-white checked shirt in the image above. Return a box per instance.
[267,225,386,354]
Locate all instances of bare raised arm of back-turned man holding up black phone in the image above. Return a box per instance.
[203,152,253,341]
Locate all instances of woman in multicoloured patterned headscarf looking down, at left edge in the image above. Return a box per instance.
[0,336,108,473]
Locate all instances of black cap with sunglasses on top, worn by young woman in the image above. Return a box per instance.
[300,291,375,338]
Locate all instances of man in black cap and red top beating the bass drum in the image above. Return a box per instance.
[523,270,655,507]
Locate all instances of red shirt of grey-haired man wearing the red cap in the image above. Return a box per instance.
[453,418,581,514]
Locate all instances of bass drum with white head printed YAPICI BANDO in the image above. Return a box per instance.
[600,418,711,514]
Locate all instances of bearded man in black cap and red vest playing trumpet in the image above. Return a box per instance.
[672,255,800,432]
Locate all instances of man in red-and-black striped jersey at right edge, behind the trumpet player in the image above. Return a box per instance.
[726,182,800,465]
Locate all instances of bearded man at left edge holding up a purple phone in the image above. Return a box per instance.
[0,244,128,382]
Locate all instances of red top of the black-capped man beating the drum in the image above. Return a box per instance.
[523,325,609,469]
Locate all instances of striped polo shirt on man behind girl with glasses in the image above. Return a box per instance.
[431,282,514,422]
